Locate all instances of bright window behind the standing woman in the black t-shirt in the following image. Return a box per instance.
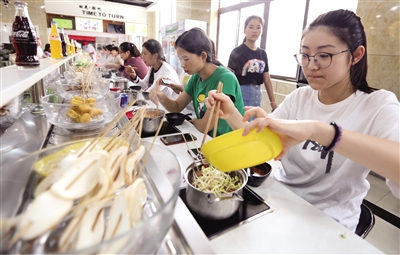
[217,0,358,80]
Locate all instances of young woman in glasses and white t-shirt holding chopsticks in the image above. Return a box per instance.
[206,10,400,231]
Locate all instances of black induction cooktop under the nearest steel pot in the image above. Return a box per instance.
[179,186,273,240]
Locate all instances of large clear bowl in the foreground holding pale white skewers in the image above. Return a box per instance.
[0,139,183,254]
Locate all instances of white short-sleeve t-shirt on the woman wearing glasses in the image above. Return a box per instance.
[272,86,399,231]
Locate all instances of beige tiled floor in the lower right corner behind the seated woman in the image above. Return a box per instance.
[365,175,400,254]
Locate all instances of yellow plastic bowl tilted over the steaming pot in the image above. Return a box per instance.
[201,128,282,172]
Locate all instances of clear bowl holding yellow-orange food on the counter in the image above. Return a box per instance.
[41,91,121,131]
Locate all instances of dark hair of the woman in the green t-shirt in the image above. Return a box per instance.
[175,27,222,66]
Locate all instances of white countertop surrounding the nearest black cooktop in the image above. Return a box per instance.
[143,100,384,254]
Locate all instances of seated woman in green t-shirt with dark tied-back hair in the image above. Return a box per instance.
[150,28,244,136]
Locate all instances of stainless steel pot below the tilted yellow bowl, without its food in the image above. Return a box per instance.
[185,163,248,220]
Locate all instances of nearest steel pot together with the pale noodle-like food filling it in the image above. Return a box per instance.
[185,162,248,220]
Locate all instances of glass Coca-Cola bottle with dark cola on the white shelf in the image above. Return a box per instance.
[12,1,40,67]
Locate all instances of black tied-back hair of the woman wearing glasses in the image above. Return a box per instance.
[303,9,376,93]
